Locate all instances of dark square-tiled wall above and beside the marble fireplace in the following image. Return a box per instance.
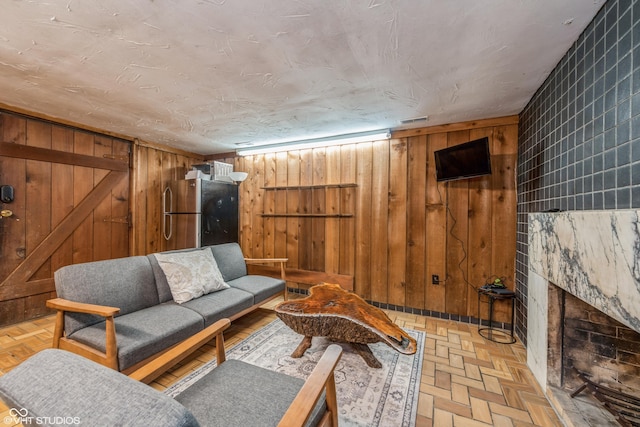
[516,0,640,344]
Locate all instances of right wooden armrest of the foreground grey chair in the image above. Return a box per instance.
[278,344,342,427]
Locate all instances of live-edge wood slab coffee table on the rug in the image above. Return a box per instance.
[275,283,417,368]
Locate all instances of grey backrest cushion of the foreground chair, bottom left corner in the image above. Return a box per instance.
[0,349,198,427]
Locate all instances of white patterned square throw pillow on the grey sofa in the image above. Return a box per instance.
[154,249,229,304]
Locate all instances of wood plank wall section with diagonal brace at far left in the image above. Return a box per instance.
[0,112,130,324]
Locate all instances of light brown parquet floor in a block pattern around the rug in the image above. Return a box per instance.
[0,301,563,427]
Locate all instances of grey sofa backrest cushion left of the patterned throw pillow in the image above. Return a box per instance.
[54,256,160,335]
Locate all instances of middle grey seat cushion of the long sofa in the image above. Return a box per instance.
[181,288,253,328]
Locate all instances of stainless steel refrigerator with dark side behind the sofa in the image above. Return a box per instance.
[162,179,239,249]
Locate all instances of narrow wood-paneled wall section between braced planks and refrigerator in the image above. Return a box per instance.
[132,142,203,255]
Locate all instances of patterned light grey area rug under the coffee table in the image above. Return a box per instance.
[165,319,425,427]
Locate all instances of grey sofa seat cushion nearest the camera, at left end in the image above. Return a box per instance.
[69,304,202,371]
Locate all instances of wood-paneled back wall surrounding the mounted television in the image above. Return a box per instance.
[235,117,518,322]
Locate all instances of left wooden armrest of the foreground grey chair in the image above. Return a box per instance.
[129,319,231,384]
